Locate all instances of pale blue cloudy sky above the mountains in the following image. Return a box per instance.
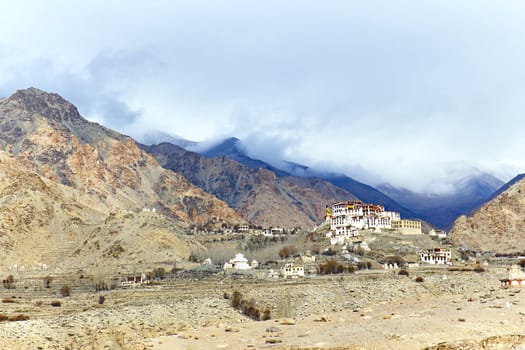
[0,0,525,193]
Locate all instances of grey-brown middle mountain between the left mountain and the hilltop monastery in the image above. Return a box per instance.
[142,140,356,228]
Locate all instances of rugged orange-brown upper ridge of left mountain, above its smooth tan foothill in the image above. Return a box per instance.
[0,88,243,225]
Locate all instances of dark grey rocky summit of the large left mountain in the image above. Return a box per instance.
[7,87,84,122]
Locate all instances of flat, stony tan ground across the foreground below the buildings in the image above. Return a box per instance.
[0,261,525,349]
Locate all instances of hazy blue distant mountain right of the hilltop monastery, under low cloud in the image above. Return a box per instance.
[378,173,503,230]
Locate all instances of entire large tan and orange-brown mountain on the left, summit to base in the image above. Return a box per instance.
[0,88,244,266]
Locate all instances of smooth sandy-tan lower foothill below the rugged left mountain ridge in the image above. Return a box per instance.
[0,151,199,271]
